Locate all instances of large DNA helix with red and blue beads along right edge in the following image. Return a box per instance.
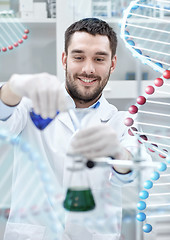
[121,0,170,234]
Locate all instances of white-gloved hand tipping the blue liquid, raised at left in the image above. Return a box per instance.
[9,73,67,118]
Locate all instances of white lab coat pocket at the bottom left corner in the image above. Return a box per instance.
[4,223,45,240]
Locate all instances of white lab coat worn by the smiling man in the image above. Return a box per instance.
[0,93,139,240]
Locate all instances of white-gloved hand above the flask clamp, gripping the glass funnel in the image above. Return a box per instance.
[68,124,128,160]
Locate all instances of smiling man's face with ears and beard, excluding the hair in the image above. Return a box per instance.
[62,32,116,105]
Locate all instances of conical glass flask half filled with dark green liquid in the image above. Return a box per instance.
[63,159,95,212]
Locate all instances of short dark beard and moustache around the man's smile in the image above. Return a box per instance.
[66,69,110,103]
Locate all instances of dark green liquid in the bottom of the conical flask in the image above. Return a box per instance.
[63,188,95,212]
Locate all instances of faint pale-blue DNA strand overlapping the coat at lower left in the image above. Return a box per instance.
[0,127,64,239]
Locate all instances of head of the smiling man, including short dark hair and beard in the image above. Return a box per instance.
[62,19,117,107]
